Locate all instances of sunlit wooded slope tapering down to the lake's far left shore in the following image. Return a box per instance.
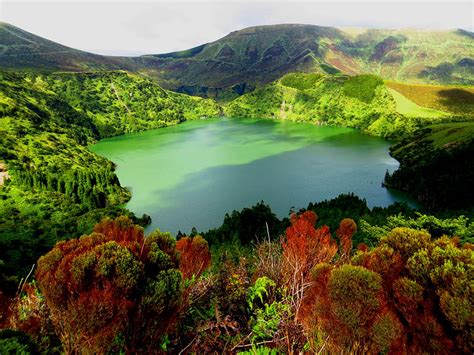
[34,71,220,138]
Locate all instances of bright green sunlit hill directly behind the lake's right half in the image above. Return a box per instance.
[224,73,472,138]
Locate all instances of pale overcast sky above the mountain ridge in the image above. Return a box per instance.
[0,0,474,55]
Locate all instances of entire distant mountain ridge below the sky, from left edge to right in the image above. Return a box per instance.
[0,23,474,99]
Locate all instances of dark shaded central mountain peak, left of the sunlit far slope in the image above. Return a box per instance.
[139,25,344,92]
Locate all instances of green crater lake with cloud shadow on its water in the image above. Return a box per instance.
[91,119,413,233]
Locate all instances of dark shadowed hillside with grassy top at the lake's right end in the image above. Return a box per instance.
[385,122,474,209]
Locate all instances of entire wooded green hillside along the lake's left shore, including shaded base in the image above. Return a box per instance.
[0,72,219,273]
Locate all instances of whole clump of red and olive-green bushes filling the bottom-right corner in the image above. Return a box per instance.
[300,229,474,354]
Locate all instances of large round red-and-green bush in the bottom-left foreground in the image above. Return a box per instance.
[36,217,182,353]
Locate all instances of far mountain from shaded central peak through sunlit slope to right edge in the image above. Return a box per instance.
[143,25,474,95]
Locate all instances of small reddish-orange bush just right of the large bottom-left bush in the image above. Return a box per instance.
[176,235,211,279]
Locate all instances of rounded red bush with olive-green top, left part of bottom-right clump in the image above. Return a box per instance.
[302,264,402,353]
